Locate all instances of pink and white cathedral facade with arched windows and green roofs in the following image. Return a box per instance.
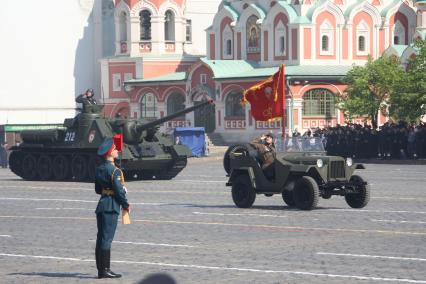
[102,0,426,141]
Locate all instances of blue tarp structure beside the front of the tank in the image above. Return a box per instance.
[174,127,205,157]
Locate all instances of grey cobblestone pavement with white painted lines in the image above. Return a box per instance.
[0,160,426,283]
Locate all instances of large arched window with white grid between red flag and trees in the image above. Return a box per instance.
[303,89,336,117]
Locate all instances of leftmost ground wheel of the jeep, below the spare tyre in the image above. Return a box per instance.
[232,174,256,208]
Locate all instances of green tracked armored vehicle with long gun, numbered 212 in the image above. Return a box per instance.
[9,101,212,181]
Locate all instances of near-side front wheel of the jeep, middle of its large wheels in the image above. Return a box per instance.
[293,176,319,210]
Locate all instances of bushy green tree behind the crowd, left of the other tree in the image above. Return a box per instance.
[337,56,404,128]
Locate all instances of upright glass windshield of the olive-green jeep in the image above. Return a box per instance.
[276,137,325,153]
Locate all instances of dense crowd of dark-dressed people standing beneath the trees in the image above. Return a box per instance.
[293,122,426,159]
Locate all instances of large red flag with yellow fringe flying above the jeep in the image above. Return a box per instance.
[241,64,285,121]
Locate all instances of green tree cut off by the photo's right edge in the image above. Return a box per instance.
[389,40,426,122]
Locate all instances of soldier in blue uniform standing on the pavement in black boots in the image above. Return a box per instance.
[95,138,130,278]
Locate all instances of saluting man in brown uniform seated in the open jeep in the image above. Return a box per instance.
[250,133,277,179]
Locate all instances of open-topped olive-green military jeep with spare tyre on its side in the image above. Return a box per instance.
[223,137,370,210]
